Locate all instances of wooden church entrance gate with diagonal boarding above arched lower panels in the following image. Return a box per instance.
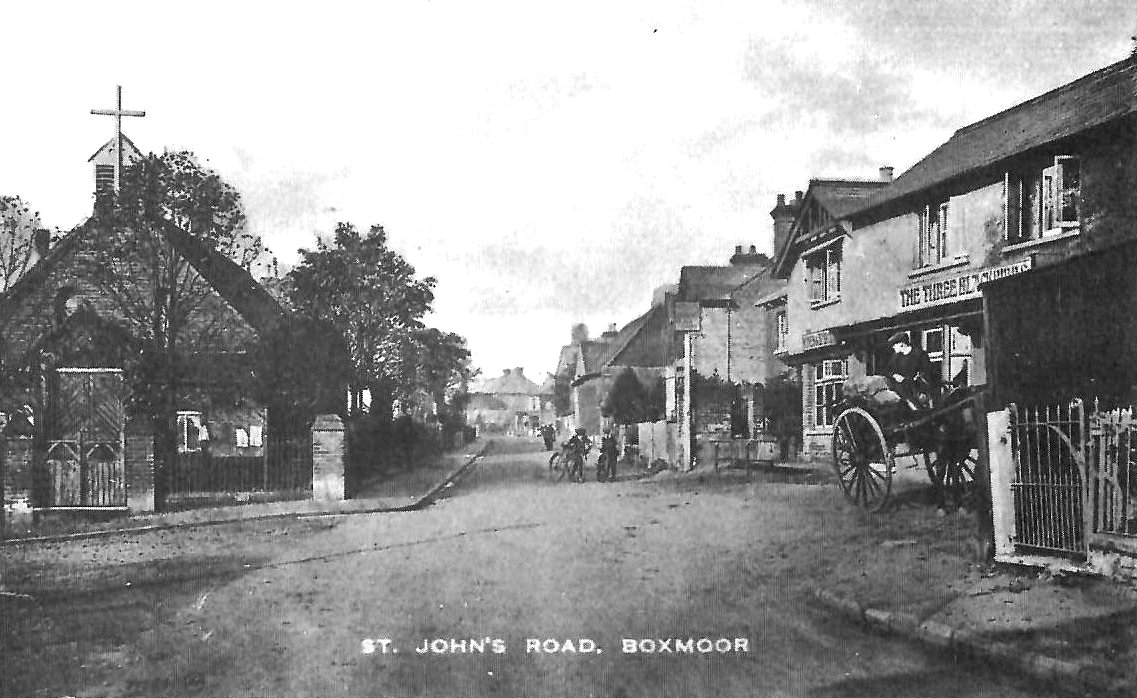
[44,368,126,507]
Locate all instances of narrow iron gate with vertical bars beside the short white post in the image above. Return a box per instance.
[1009,400,1089,557]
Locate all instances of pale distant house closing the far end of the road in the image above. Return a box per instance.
[466,367,553,435]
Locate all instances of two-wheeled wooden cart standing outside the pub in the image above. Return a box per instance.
[833,377,980,512]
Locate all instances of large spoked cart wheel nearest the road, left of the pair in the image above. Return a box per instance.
[833,407,893,512]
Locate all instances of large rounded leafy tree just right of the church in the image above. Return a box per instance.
[289,223,435,413]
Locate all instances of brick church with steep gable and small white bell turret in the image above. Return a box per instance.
[0,93,347,526]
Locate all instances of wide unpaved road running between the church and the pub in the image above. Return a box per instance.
[0,441,1057,698]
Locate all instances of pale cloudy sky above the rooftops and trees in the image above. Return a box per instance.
[0,0,1137,382]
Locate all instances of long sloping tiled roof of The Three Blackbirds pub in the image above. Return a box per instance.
[855,57,1137,221]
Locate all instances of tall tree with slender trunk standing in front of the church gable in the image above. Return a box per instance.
[90,151,266,507]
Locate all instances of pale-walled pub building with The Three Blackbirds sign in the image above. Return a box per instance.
[771,58,1137,456]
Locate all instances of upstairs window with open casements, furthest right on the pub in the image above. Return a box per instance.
[1004,155,1081,243]
